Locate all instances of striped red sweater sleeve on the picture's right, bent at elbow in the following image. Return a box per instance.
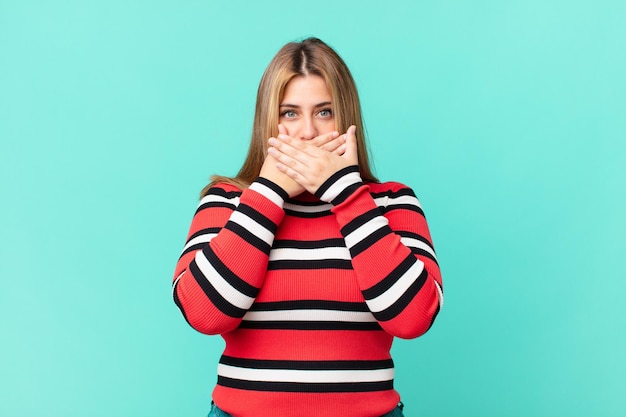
[316,166,443,338]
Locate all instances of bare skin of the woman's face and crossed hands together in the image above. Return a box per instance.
[260,75,358,197]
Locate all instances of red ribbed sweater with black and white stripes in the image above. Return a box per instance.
[173,167,443,417]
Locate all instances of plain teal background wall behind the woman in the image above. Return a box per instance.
[0,0,626,417]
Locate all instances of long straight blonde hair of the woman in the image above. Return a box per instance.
[200,38,378,196]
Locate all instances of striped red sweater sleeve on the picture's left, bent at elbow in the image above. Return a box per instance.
[173,178,287,334]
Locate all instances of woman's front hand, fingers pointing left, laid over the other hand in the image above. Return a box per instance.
[268,126,359,194]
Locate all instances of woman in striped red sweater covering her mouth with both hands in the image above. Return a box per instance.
[173,38,443,417]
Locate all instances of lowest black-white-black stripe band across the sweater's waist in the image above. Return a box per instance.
[217,355,394,392]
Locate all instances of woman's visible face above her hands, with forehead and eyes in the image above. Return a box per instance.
[279,75,335,140]
